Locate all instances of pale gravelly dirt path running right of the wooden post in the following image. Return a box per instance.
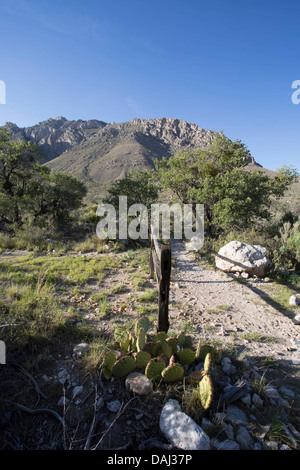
[170,241,300,363]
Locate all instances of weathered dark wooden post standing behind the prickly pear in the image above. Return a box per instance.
[149,226,172,332]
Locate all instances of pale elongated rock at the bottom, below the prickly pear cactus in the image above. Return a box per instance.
[159,399,210,450]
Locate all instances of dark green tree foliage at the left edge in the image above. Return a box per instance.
[0,128,86,230]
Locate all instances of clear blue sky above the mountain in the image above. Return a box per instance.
[0,0,300,170]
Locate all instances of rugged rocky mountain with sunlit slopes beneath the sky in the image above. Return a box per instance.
[5,116,260,200]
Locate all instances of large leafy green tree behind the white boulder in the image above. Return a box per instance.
[155,133,296,234]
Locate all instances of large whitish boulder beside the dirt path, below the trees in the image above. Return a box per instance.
[215,241,271,277]
